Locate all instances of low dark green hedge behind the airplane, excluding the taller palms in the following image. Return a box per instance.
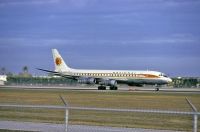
[6,76,200,88]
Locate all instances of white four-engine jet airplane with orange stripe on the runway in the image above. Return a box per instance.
[37,49,172,91]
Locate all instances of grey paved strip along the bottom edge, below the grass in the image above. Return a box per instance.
[0,121,180,132]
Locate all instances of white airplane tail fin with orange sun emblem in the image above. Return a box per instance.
[52,49,71,72]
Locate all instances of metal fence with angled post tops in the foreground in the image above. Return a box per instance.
[0,97,200,132]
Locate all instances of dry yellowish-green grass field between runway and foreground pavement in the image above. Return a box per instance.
[0,89,200,131]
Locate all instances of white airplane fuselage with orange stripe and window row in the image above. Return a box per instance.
[63,69,172,84]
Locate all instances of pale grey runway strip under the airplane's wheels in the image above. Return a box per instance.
[0,85,200,94]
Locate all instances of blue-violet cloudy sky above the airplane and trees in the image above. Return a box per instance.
[0,0,200,77]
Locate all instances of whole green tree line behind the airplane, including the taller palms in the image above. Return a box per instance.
[0,66,200,87]
